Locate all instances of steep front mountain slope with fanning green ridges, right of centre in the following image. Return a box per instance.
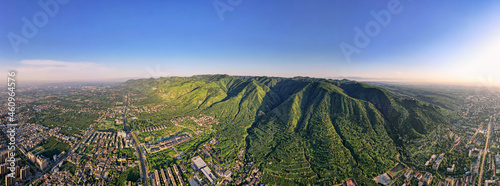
[248,82,398,184]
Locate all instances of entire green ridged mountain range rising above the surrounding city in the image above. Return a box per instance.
[123,75,449,185]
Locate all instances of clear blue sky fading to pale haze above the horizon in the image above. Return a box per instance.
[0,0,500,84]
